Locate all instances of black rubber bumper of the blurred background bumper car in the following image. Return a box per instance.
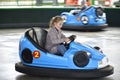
[62,24,108,30]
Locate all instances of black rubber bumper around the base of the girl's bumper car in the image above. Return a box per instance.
[15,62,114,78]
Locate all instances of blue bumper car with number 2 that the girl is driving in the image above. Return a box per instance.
[15,28,114,78]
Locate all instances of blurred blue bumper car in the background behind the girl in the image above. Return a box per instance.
[60,6,108,30]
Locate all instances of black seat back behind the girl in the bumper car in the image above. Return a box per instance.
[26,27,47,51]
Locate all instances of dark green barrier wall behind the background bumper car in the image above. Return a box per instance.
[0,8,120,28]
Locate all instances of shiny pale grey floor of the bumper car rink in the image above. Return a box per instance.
[0,27,120,80]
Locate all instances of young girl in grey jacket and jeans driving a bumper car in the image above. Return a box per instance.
[45,16,70,55]
